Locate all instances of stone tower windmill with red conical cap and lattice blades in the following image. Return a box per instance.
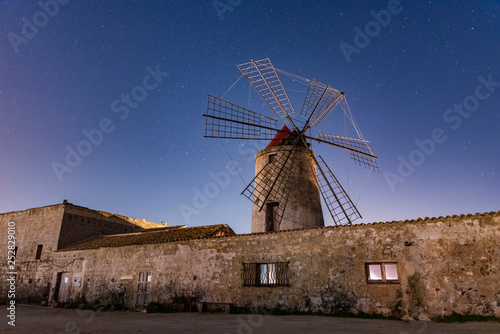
[203,58,378,233]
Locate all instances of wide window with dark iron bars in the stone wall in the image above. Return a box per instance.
[241,262,290,286]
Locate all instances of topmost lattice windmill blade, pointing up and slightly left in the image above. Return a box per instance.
[236,58,295,118]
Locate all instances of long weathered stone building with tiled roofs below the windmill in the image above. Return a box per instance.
[0,202,500,319]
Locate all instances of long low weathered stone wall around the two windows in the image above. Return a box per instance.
[45,213,500,319]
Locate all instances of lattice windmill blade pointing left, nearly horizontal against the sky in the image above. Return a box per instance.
[203,95,280,140]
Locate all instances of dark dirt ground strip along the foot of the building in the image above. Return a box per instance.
[0,305,500,334]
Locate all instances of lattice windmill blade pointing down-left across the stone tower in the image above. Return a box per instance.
[242,146,297,225]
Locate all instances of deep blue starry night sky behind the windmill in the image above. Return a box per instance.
[0,0,500,233]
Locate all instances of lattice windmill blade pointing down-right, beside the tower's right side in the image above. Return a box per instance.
[314,156,361,226]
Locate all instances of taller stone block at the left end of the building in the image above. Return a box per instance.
[0,203,162,303]
